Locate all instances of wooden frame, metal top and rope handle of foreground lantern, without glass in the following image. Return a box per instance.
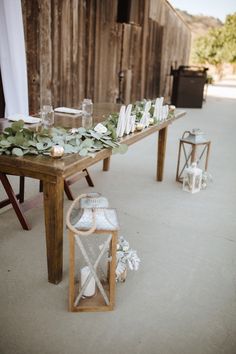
[66,193,119,312]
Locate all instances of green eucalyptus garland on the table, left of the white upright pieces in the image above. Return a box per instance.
[0,120,128,157]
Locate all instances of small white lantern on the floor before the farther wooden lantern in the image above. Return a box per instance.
[183,162,202,193]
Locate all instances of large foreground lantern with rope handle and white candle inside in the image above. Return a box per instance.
[66,193,119,312]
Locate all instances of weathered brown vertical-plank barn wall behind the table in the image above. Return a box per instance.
[22,0,190,112]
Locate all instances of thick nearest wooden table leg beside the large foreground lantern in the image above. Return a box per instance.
[43,178,64,284]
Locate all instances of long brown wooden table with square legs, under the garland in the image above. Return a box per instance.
[0,104,185,284]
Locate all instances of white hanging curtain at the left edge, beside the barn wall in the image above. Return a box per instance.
[0,0,29,117]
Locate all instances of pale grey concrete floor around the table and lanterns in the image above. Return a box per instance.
[0,81,236,354]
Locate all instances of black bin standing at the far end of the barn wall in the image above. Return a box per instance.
[171,66,208,108]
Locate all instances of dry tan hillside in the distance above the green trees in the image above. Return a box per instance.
[176,9,223,38]
